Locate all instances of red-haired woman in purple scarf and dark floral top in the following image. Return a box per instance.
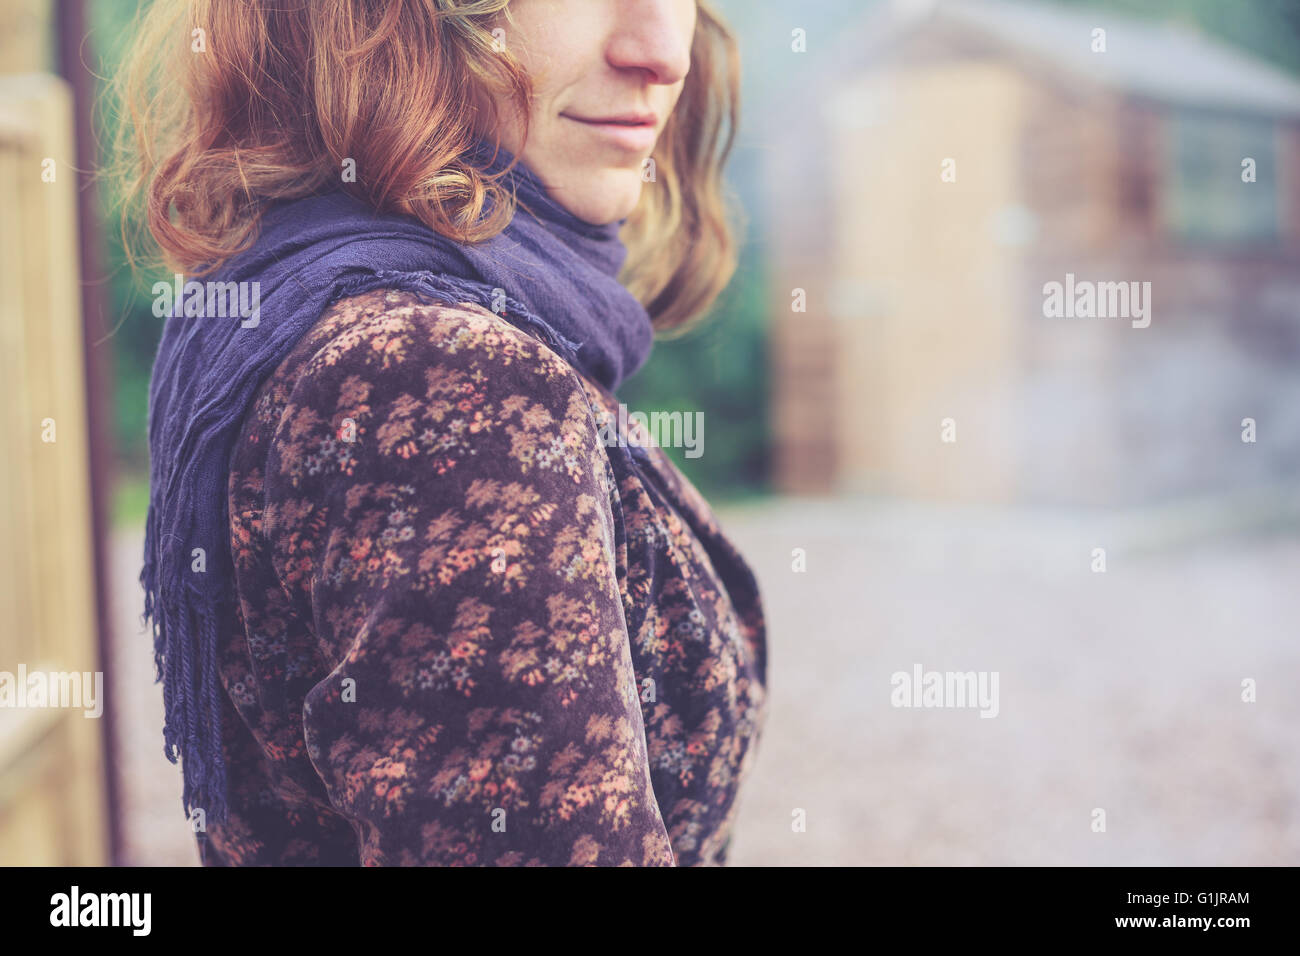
[118,0,766,865]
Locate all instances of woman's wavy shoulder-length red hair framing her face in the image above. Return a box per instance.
[109,0,740,332]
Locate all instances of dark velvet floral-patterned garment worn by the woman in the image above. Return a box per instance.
[208,290,766,866]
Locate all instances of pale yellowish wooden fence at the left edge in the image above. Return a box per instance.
[0,73,108,865]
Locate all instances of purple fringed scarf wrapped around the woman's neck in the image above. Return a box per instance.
[140,144,654,819]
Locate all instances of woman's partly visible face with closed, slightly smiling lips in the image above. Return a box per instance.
[488,0,696,225]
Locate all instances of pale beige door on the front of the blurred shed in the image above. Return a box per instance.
[832,61,1024,501]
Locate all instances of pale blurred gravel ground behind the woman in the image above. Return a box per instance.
[111,499,1300,865]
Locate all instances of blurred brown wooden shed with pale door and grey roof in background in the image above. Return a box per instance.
[766,0,1300,503]
